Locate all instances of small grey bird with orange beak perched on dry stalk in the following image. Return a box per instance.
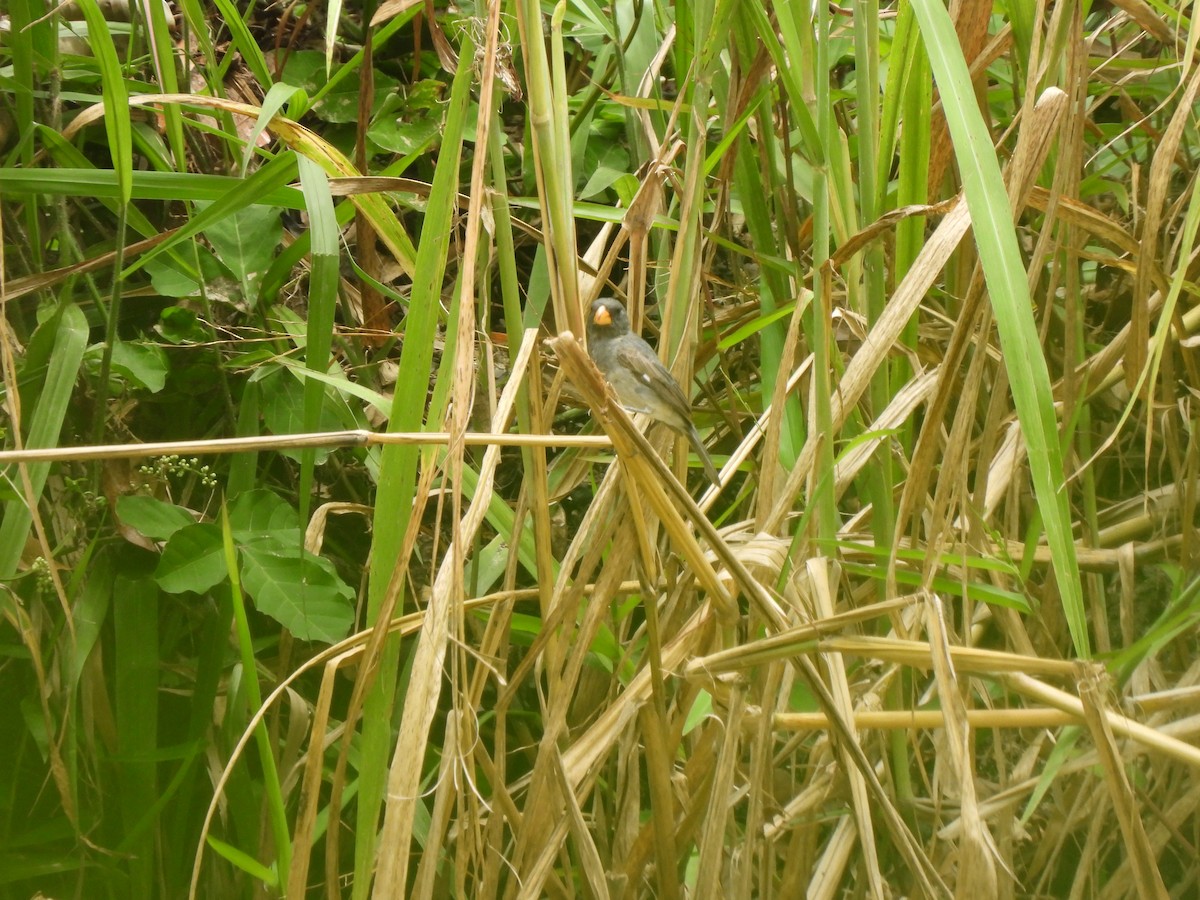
[588,296,720,485]
